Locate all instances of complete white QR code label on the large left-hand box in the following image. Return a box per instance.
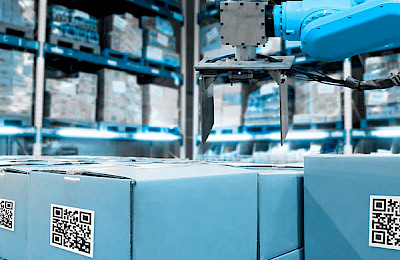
[50,204,94,258]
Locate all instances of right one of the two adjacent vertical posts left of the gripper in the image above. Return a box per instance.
[192,0,200,160]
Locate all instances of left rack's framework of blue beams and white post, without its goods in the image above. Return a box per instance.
[0,0,186,156]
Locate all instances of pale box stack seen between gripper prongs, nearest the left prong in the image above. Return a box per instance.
[214,83,248,127]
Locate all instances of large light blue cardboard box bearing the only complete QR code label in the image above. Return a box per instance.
[28,163,257,260]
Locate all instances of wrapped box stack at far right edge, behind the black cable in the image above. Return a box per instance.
[364,54,400,119]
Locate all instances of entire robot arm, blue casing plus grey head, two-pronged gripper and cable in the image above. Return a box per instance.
[195,0,400,144]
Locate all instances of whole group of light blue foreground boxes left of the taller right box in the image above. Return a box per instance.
[0,157,303,260]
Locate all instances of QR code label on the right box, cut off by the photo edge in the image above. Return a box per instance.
[369,196,400,250]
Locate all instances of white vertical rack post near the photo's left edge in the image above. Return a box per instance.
[33,0,47,156]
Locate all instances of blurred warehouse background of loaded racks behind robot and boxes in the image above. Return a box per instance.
[0,0,400,163]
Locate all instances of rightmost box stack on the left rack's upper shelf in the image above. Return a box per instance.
[142,16,180,67]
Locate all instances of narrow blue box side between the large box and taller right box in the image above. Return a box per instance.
[258,168,304,260]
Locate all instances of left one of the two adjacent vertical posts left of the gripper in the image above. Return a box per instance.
[180,0,188,158]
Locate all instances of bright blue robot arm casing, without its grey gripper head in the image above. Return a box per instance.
[274,0,400,61]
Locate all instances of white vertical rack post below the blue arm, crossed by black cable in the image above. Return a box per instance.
[343,59,353,154]
